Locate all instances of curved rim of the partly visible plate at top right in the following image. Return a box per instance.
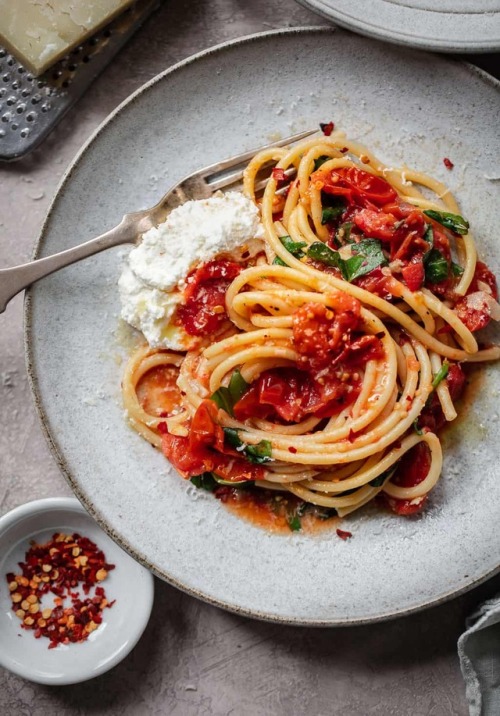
[296,0,500,54]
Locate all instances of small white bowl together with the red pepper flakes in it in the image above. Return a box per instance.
[0,498,153,684]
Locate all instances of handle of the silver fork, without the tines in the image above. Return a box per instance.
[0,212,145,313]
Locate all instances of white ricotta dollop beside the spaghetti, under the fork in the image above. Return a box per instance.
[118,192,264,350]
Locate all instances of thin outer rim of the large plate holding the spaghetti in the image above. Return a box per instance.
[23,25,500,628]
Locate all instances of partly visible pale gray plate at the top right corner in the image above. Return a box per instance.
[298,0,500,52]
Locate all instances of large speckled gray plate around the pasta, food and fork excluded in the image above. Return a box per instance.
[26,28,500,625]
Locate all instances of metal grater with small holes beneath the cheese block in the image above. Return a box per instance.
[0,0,160,161]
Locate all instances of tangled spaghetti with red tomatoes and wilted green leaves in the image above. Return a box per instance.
[123,132,500,529]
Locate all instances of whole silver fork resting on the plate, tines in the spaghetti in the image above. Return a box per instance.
[0,129,317,313]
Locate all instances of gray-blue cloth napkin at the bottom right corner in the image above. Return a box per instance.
[458,595,500,716]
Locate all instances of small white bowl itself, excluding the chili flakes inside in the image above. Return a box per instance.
[0,498,154,684]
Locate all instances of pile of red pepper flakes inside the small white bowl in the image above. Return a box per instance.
[6,532,115,649]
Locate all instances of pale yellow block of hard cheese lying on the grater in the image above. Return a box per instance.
[0,0,134,75]
